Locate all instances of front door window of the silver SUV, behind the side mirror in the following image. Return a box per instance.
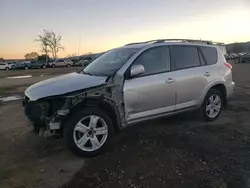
[133,46,170,76]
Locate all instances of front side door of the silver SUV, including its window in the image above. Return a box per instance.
[123,46,175,122]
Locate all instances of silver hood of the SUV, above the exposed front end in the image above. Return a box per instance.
[25,72,107,101]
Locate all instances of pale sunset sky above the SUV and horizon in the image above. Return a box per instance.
[0,0,250,59]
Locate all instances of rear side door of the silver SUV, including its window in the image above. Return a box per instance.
[171,45,210,110]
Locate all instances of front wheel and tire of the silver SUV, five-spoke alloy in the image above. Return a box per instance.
[64,108,114,157]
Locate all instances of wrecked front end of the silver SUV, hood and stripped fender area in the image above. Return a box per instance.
[23,70,126,137]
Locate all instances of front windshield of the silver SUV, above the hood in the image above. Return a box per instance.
[83,48,138,76]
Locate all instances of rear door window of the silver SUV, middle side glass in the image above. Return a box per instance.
[172,46,200,70]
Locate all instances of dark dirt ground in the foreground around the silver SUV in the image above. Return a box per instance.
[0,64,250,188]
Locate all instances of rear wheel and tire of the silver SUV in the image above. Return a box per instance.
[201,89,224,122]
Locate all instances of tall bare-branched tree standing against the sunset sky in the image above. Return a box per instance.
[35,30,64,58]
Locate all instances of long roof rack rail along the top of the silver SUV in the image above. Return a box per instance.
[125,39,224,46]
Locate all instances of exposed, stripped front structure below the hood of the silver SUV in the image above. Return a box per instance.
[23,84,125,137]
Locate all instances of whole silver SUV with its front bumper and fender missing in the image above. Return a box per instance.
[23,39,234,156]
